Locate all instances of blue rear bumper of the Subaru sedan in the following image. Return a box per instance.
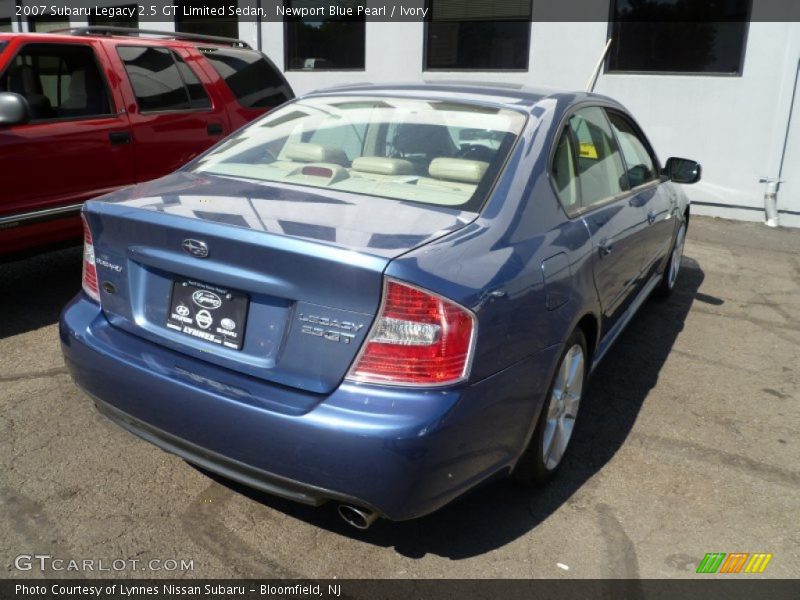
[60,294,559,520]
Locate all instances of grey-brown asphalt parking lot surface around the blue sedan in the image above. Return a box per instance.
[0,217,800,578]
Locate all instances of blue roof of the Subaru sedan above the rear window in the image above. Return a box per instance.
[307,81,623,109]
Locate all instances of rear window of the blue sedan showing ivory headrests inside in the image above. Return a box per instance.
[189,96,525,211]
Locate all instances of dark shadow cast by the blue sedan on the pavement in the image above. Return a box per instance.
[203,257,708,560]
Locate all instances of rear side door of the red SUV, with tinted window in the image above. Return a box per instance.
[107,42,230,181]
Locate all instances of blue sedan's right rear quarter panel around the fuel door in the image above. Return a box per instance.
[387,100,597,381]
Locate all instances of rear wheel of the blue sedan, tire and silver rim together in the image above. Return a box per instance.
[514,330,587,485]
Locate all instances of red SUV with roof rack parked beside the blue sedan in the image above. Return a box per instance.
[0,27,293,258]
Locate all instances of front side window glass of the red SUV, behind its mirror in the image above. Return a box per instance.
[0,44,111,120]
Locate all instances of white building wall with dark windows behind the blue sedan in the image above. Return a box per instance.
[276,22,800,226]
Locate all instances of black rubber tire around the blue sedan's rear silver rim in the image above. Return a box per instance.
[512,329,589,486]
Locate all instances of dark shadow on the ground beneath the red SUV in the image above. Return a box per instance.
[0,246,83,339]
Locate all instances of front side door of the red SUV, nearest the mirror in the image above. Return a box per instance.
[0,40,136,254]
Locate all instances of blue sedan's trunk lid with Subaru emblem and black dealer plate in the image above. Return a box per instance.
[85,173,468,393]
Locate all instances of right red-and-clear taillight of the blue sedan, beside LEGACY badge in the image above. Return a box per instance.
[348,280,475,386]
